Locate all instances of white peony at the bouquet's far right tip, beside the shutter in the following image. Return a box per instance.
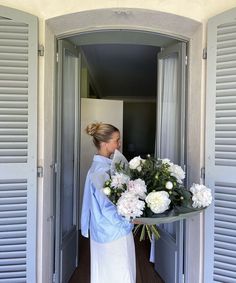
[190,184,212,208]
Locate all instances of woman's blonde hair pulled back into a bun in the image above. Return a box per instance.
[85,123,119,149]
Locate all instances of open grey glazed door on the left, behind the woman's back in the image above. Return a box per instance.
[55,40,80,283]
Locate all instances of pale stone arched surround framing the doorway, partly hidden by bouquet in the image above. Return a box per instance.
[40,8,204,283]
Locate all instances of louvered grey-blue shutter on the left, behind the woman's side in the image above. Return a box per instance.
[0,6,37,283]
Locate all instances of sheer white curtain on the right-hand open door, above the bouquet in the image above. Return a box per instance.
[160,55,181,164]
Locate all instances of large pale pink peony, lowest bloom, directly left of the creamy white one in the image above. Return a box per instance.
[117,191,145,220]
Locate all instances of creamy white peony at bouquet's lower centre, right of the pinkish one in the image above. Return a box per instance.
[145,191,170,213]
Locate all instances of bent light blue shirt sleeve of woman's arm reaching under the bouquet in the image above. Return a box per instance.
[91,172,133,231]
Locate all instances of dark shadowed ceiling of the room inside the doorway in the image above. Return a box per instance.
[82,44,159,97]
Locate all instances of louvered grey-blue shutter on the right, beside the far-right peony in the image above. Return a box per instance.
[204,6,236,283]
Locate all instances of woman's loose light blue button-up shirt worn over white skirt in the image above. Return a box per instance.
[81,155,133,243]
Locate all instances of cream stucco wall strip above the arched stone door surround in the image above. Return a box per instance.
[0,0,236,22]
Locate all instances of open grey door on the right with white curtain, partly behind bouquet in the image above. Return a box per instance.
[155,43,186,283]
